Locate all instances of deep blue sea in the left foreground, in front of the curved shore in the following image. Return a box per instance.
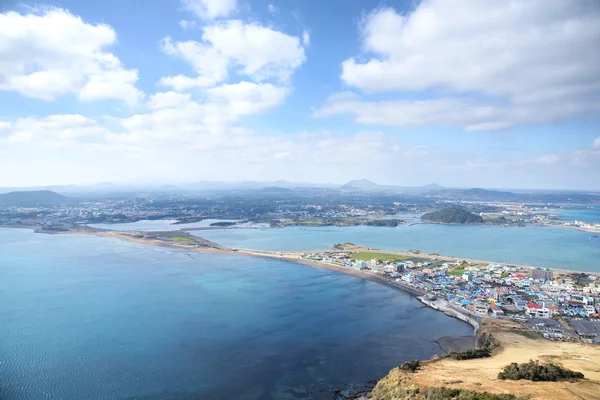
[0,229,472,400]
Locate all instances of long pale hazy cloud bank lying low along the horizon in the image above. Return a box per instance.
[0,108,600,189]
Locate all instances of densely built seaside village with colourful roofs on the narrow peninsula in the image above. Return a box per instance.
[299,251,600,344]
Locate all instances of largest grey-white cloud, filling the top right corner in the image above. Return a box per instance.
[318,0,600,129]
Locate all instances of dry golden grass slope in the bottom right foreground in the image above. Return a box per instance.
[372,320,600,400]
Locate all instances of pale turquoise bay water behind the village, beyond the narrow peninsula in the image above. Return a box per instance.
[191,224,600,272]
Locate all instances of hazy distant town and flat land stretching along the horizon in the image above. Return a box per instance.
[0,187,600,233]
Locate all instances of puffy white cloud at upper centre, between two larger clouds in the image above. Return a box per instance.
[159,20,306,90]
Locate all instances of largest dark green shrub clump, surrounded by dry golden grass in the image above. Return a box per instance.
[498,360,584,382]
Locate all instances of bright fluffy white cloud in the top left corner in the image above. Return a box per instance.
[0,8,143,106]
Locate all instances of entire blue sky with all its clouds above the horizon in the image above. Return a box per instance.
[0,0,600,190]
